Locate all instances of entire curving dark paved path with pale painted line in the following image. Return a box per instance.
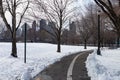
[33,51,92,80]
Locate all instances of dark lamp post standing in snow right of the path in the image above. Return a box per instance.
[97,10,101,55]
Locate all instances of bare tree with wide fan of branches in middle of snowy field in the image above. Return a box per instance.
[37,0,74,52]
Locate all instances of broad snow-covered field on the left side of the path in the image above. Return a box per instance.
[0,43,94,80]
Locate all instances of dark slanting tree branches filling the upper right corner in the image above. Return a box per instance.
[94,0,120,47]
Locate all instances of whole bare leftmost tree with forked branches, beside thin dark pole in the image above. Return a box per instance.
[0,0,29,57]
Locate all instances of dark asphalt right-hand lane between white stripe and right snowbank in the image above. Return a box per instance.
[72,52,90,80]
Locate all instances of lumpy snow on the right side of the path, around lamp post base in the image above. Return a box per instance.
[86,49,120,80]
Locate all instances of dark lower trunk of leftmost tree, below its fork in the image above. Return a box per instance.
[11,32,17,57]
